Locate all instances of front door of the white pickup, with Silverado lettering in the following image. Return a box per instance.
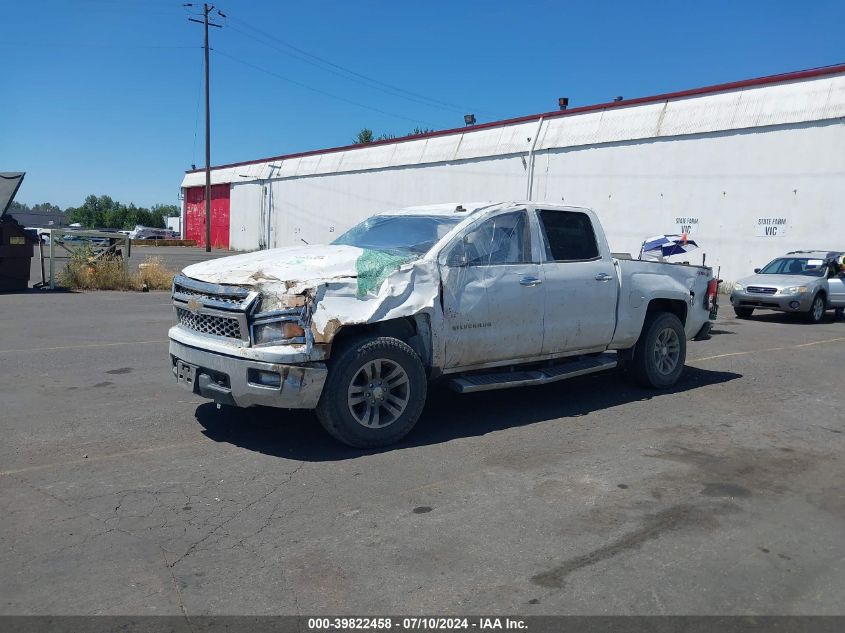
[440,211,543,369]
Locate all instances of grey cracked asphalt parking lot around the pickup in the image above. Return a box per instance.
[0,292,845,615]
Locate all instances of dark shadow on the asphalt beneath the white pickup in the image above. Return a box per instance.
[195,367,742,462]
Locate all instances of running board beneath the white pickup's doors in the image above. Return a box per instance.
[449,352,617,393]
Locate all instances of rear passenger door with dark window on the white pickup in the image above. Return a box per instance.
[537,208,618,354]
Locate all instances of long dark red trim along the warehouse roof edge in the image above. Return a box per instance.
[185,64,845,174]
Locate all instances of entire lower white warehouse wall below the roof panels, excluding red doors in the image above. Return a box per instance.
[242,120,845,279]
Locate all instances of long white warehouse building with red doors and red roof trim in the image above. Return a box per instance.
[182,65,845,280]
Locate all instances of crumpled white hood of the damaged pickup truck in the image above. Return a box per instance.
[182,244,364,286]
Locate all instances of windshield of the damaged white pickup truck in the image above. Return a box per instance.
[332,215,464,257]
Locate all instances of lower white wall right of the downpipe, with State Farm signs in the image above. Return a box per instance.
[534,119,845,280]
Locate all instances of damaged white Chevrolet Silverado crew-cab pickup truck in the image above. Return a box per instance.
[169,202,717,447]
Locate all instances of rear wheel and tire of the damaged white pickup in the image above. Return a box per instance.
[629,312,687,389]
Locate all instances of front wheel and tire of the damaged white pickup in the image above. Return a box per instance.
[316,337,428,448]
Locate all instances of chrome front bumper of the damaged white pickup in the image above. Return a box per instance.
[170,338,328,409]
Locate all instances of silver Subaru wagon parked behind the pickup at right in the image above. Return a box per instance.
[731,251,845,323]
